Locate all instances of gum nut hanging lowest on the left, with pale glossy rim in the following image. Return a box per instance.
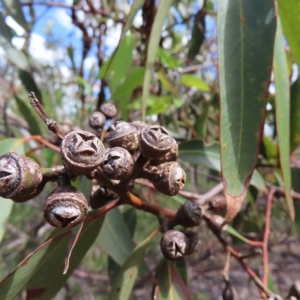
[44,185,88,228]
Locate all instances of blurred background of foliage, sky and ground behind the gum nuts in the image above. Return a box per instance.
[0,0,300,299]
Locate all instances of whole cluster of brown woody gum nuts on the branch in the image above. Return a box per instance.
[0,103,206,260]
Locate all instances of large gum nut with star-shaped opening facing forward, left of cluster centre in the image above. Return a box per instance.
[61,130,105,175]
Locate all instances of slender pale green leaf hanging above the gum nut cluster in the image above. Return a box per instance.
[142,0,173,121]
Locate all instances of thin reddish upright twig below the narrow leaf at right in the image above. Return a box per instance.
[262,189,275,286]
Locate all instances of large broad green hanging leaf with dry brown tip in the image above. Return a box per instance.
[218,0,276,222]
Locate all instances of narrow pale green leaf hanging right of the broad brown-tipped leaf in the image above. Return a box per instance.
[274,19,295,220]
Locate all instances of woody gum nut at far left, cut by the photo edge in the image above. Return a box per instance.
[0,152,43,202]
